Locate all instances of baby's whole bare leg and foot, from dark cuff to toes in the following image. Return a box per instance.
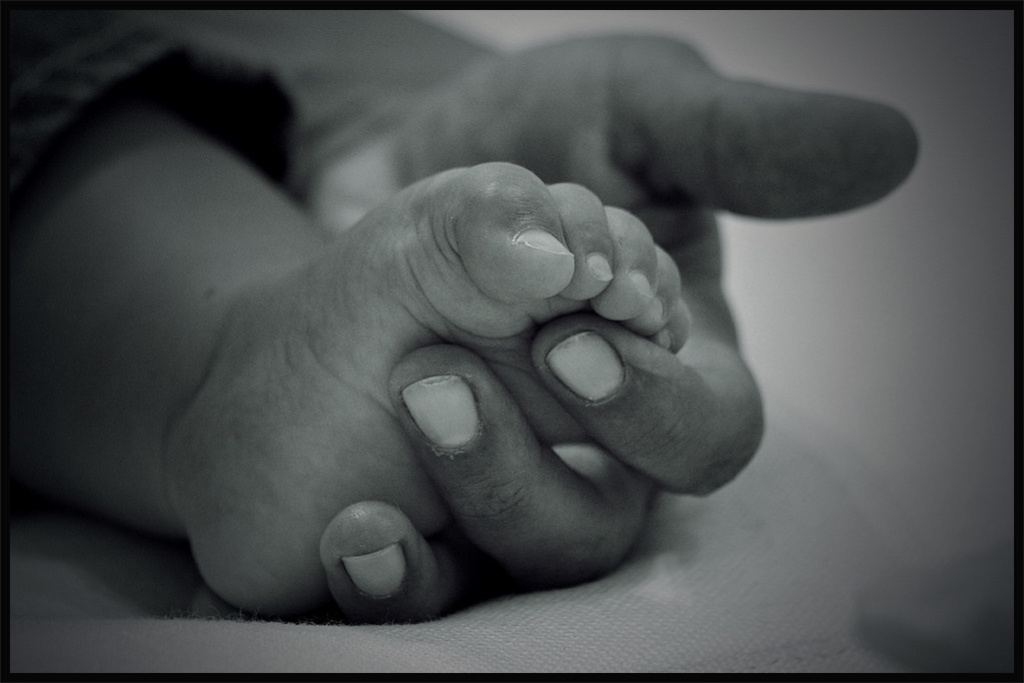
[11,90,681,614]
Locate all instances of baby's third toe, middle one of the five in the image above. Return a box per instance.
[591,207,664,321]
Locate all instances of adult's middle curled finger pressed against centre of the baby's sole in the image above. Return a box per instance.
[389,345,652,588]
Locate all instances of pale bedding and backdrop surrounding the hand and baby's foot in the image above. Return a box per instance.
[8,10,1019,672]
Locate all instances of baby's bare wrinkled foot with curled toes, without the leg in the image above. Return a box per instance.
[167,164,686,614]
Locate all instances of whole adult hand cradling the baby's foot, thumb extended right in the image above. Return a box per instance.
[313,31,916,621]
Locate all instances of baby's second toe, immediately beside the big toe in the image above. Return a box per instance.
[549,183,615,301]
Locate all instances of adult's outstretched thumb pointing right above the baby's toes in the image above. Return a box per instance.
[608,38,918,218]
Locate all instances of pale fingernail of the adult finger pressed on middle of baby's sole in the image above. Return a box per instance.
[401,375,479,449]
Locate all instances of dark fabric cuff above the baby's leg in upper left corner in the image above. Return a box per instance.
[6,9,290,200]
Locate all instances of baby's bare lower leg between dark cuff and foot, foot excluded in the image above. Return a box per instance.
[9,97,324,537]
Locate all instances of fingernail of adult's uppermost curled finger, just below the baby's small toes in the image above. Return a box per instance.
[548,332,625,400]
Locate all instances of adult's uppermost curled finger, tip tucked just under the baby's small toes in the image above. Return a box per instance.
[532,313,764,495]
